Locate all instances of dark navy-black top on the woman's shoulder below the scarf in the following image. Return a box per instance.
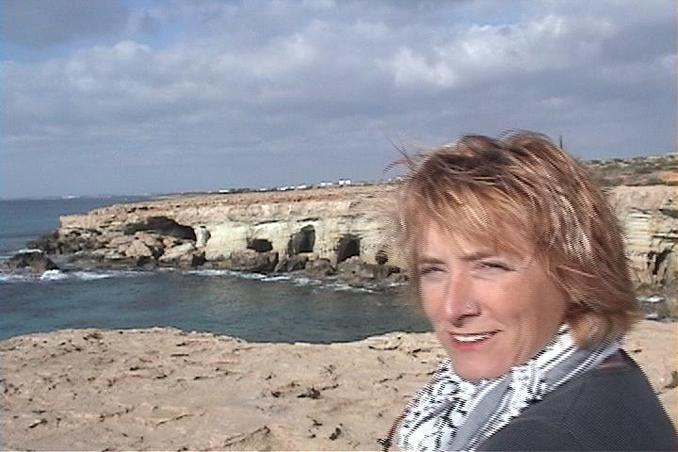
[479,352,678,451]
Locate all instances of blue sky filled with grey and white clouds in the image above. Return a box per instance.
[0,0,676,198]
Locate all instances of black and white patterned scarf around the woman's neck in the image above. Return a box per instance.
[398,325,619,451]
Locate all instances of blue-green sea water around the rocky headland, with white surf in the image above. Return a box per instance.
[0,196,429,343]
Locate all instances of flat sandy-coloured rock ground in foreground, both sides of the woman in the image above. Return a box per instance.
[0,321,678,450]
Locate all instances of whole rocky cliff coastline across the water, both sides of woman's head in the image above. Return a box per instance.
[4,185,678,319]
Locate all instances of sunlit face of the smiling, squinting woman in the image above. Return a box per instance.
[417,225,567,380]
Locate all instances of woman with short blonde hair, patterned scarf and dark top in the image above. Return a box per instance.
[390,132,678,450]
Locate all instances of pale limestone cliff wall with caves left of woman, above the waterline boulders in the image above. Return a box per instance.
[57,186,402,274]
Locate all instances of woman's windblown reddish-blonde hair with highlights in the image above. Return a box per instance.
[397,131,639,347]
